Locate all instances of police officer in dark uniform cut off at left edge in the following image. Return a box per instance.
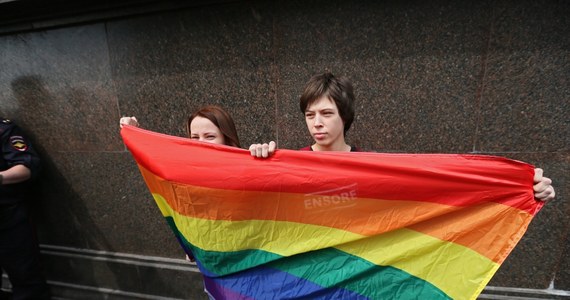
[0,118,50,300]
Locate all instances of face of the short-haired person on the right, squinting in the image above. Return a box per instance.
[305,97,344,147]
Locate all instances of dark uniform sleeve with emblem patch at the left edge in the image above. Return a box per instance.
[0,120,40,178]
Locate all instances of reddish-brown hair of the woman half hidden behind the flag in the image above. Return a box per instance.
[186,105,240,148]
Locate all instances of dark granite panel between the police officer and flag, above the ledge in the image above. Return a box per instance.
[35,152,184,258]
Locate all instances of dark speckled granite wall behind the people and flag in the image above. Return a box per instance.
[0,0,570,299]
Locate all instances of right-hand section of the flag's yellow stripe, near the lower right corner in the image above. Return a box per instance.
[336,228,499,299]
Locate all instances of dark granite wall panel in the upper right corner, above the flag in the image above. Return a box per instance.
[477,1,570,152]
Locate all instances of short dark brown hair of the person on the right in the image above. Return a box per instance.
[299,72,354,135]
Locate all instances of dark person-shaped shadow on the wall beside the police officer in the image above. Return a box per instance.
[12,76,109,290]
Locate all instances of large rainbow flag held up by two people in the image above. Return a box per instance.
[121,126,542,299]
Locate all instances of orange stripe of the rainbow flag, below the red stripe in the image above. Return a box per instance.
[140,166,532,263]
